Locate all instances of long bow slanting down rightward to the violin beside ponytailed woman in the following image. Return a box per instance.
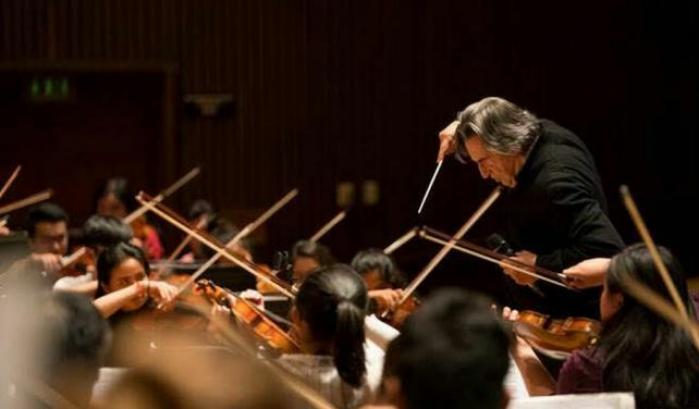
[136,192,295,299]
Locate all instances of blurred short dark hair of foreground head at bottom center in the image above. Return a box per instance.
[384,288,510,409]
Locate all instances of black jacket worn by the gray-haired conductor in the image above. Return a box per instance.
[503,120,624,316]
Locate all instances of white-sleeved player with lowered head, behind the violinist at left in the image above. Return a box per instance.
[53,215,133,296]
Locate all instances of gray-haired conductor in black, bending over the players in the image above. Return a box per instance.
[438,97,623,317]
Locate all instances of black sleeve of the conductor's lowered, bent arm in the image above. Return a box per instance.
[536,169,624,271]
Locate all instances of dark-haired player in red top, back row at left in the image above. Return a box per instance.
[95,178,163,260]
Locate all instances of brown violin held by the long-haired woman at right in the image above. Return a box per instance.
[512,310,602,359]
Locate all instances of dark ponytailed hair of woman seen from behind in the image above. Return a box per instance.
[295,264,368,388]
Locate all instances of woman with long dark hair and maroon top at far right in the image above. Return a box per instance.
[510,244,699,408]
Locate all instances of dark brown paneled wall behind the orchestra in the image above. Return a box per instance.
[0,0,699,300]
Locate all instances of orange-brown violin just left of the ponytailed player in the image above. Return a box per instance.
[194,280,301,354]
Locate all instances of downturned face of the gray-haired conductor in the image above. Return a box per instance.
[466,135,521,187]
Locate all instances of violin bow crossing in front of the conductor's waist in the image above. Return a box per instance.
[419,227,575,291]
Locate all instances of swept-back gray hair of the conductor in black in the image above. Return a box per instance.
[456,97,541,160]
